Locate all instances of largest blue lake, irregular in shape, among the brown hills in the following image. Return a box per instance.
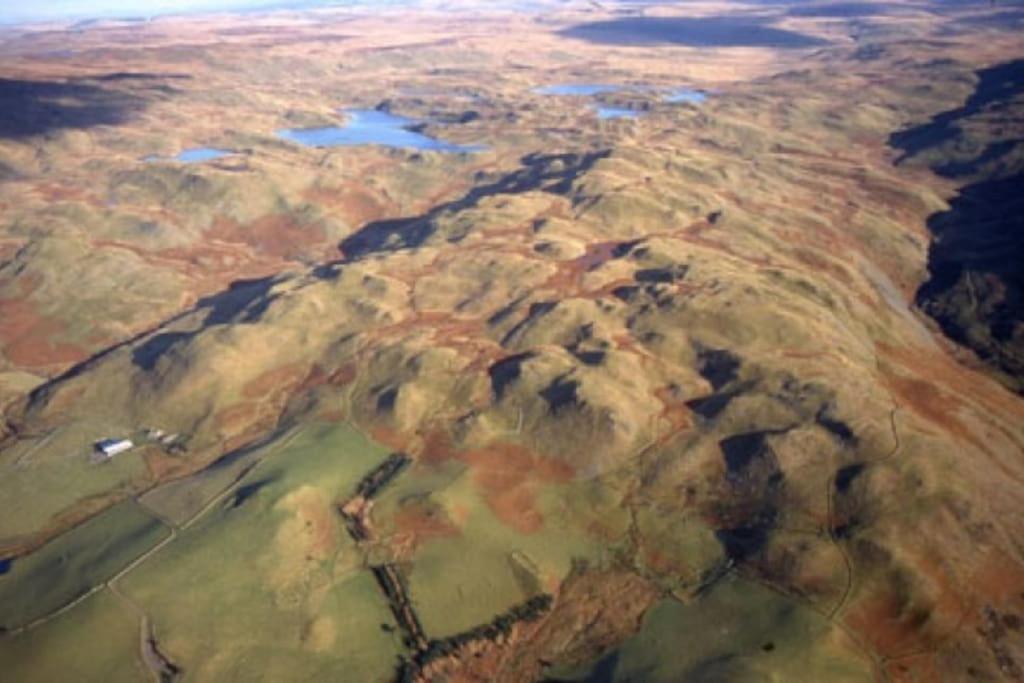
[278,110,484,152]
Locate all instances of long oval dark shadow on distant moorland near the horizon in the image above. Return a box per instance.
[559,16,828,49]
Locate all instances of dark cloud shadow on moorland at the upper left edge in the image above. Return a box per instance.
[0,79,145,139]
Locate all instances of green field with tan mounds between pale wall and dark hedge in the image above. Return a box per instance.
[114,426,400,681]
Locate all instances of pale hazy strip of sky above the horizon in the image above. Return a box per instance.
[0,0,382,24]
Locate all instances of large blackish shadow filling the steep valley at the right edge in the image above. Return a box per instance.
[889,59,1024,393]
